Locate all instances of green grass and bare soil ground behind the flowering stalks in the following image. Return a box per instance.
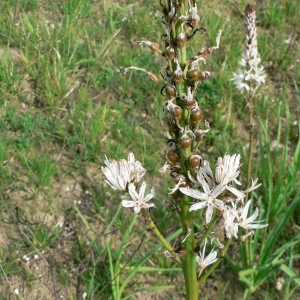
[0,0,300,300]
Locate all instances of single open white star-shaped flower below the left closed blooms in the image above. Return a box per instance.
[122,181,155,214]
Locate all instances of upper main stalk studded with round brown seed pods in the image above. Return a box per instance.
[135,0,219,186]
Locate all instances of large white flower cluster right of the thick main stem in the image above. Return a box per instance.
[179,154,267,238]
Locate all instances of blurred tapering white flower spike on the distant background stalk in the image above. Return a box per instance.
[231,4,266,95]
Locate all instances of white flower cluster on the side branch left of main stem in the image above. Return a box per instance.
[101,153,155,214]
